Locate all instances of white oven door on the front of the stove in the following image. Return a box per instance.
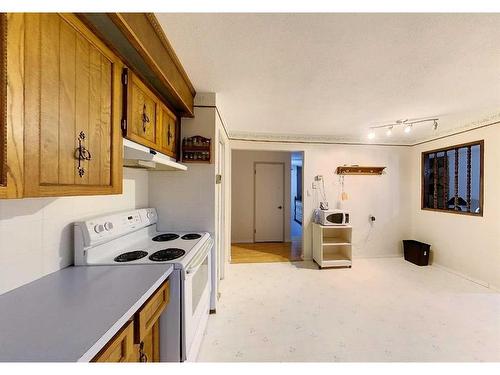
[183,239,213,361]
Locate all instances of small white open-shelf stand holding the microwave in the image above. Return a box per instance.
[313,223,352,268]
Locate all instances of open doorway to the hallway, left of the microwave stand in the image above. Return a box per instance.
[231,150,303,263]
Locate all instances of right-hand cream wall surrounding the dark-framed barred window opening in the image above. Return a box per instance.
[410,125,500,289]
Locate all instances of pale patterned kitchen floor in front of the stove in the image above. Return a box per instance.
[198,258,500,362]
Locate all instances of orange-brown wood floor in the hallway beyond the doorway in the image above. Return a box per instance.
[231,241,302,263]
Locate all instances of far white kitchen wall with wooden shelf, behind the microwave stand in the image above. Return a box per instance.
[231,141,411,259]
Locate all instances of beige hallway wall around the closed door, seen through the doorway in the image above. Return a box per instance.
[231,150,291,243]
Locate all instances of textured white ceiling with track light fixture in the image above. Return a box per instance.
[157,13,500,144]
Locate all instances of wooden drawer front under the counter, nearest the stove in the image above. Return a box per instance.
[135,281,170,344]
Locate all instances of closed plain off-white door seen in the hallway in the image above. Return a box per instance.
[254,163,285,242]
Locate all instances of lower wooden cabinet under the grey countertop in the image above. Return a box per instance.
[92,281,170,362]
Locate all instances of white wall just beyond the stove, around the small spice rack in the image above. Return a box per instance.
[149,101,230,309]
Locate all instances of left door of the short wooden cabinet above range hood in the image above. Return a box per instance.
[126,72,158,149]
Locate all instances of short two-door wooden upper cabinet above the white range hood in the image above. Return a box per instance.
[124,69,178,158]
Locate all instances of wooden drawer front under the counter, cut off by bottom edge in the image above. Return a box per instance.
[92,321,136,362]
